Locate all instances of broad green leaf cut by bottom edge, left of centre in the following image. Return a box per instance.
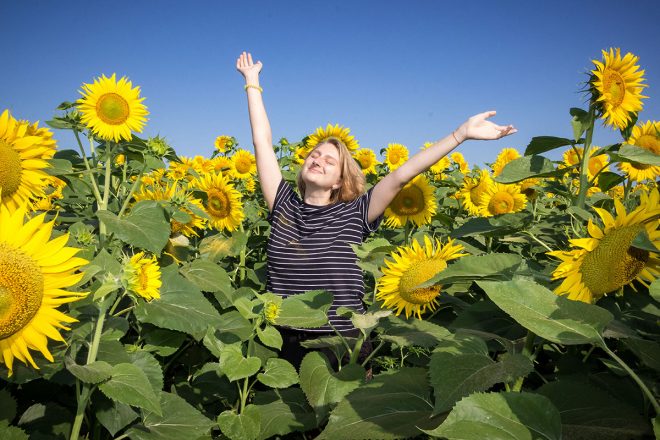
[126,393,215,440]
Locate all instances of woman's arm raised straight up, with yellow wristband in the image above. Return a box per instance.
[236,52,282,211]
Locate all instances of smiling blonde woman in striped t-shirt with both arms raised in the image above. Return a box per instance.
[236,52,516,366]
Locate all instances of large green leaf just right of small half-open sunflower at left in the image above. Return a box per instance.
[134,265,221,340]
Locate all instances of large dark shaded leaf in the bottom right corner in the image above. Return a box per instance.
[537,377,651,440]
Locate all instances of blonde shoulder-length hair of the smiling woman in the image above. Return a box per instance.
[296,137,366,203]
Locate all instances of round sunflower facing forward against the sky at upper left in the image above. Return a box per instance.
[78,73,149,142]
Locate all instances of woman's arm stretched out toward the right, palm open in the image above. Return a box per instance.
[368,110,518,222]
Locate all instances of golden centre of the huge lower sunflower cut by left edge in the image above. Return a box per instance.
[0,243,44,340]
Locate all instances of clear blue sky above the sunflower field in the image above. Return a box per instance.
[0,0,660,164]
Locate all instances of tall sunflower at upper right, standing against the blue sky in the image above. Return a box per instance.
[591,48,648,130]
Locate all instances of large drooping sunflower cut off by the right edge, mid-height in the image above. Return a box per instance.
[548,189,660,303]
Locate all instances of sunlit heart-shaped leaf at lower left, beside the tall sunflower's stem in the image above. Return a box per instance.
[99,364,162,415]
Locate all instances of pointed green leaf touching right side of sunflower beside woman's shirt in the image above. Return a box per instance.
[417,253,522,288]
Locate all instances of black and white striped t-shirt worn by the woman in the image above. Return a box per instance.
[266,179,383,332]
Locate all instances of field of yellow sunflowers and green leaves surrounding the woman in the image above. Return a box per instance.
[0,49,660,440]
